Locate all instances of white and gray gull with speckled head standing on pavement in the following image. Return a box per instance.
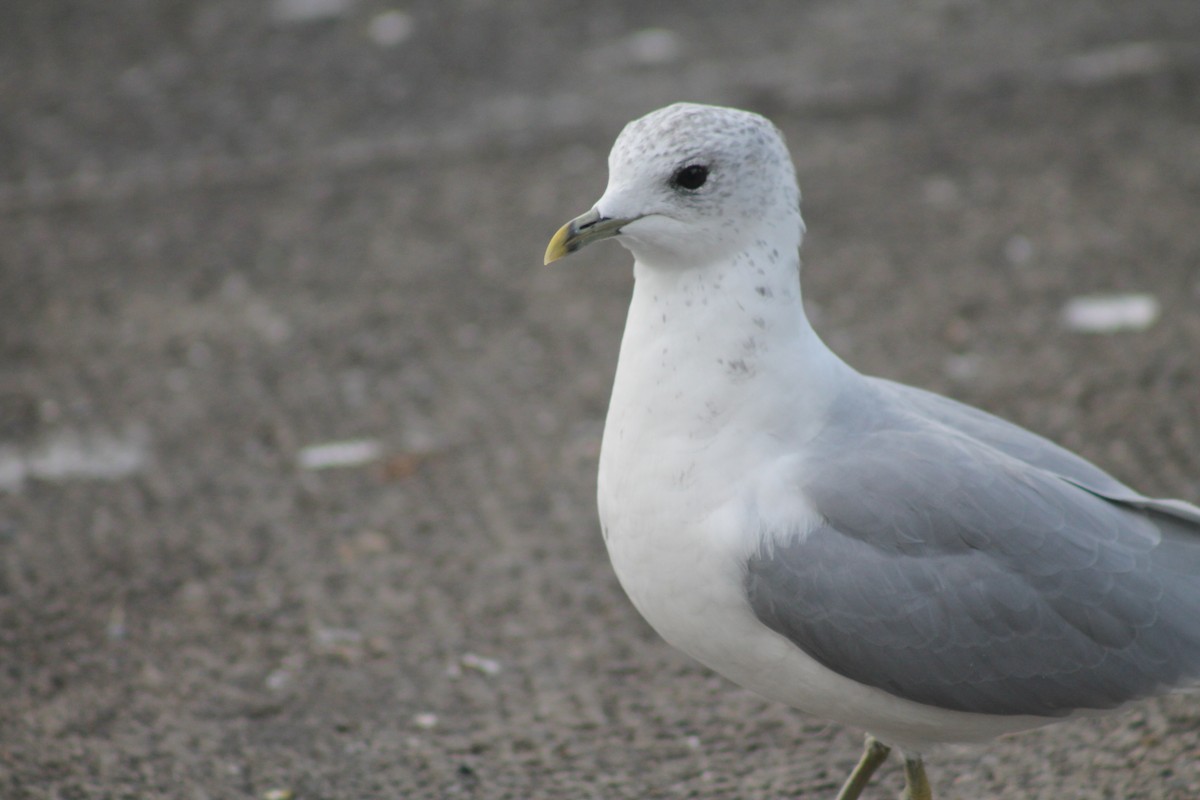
[545,103,1200,800]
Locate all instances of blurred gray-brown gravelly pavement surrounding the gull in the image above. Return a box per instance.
[0,0,1200,800]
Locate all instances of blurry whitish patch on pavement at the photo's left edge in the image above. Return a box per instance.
[0,426,150,492]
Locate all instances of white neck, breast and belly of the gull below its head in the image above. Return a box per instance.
[598,255,1046,751]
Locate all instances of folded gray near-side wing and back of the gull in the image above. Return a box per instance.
[745,381,1200,716]
